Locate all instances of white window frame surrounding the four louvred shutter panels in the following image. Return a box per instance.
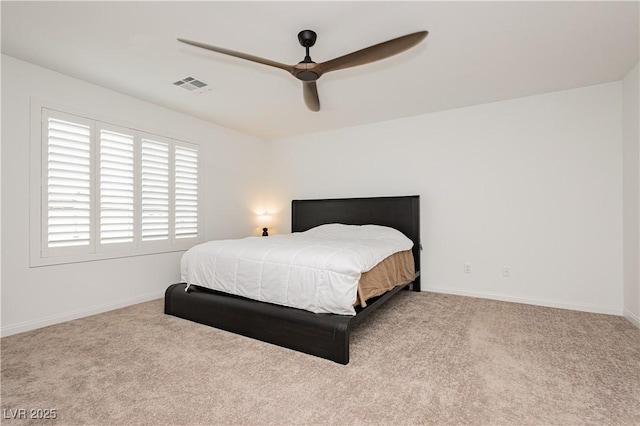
[29,98,204,267]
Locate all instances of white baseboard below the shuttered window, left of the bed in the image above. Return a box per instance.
[0,291,164,337]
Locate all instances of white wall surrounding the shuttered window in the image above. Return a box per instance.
[1,56,265,335]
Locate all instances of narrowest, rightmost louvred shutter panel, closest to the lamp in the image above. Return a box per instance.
[174,145,198,238]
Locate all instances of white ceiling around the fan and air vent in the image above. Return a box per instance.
[2,1,640,139]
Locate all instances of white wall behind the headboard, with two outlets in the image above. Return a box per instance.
[269,83,623,315]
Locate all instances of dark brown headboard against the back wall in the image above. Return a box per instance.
[291,195,420,291]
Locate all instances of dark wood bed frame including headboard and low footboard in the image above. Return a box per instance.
[164,195,420,364]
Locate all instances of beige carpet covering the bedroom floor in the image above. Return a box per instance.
[1,292,640,425]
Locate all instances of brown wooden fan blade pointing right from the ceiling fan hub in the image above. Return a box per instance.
[316,31,429,74]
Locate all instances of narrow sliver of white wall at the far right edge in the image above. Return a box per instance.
[622,61,640,327]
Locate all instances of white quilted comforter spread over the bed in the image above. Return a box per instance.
[181,224,413,315]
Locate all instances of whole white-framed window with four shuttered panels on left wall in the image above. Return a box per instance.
[32,108,200,265]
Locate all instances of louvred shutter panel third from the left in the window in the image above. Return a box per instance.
[141,138,169,241]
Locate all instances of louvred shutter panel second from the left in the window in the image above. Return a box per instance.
[100,129,135,244]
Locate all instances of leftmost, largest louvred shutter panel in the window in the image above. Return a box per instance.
[46,116,91,248]
